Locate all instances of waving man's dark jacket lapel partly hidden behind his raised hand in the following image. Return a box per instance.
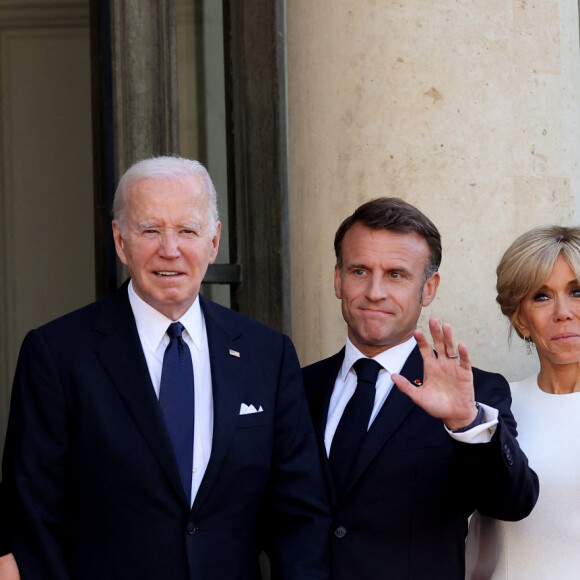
[346,347,423,493]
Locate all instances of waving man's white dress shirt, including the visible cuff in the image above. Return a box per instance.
[324,337,499,455]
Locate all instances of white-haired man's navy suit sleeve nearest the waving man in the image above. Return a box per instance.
[265,337,330,580]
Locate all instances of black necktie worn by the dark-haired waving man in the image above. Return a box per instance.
[328,358,382,497]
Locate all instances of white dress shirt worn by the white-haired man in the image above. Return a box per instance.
[129,282,213,505]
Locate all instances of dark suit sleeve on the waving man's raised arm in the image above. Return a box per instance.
[454,369,539,521]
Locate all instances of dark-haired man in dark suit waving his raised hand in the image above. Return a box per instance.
[303,198,538,580]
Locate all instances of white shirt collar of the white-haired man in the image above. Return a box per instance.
[128,281,204,352]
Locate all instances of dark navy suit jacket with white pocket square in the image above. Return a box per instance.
[4,285,329,580]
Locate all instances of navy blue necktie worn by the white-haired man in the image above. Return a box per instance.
[159,322,194,502]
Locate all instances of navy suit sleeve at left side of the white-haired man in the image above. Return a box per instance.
[3,331,69,580]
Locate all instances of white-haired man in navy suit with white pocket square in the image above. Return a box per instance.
[4,157,330,580]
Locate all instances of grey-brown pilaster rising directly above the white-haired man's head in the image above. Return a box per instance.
[111,0,179,177]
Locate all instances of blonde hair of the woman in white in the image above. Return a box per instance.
[496,226,580,338]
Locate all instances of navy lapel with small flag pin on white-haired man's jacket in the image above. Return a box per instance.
[193,296,245,509]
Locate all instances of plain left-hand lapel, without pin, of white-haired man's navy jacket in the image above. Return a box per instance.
[94,284,187,503]
